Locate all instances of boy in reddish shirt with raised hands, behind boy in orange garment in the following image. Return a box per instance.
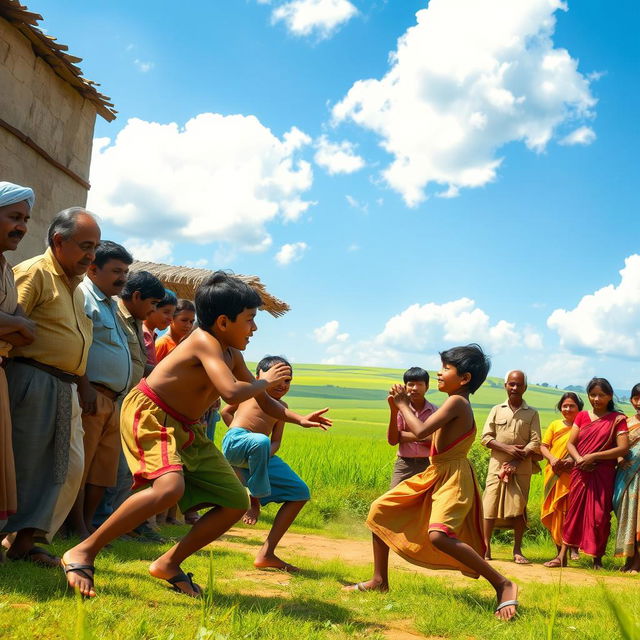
[387,367,438,489]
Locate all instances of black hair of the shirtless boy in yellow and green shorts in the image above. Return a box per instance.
[196,271,262,331]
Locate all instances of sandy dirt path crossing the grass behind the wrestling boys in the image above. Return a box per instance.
[214,527,633,588]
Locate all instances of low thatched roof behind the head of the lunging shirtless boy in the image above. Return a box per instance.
[130,260,290,318]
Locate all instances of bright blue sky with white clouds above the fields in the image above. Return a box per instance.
[29,0,640,389]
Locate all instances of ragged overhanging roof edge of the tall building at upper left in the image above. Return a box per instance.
[0,0,117,122]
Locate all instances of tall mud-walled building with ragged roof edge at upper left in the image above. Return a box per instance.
[0,0,116,264]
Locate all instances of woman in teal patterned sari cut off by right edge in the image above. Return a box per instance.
[613,383,640,574]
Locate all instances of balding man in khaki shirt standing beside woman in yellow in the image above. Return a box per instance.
[482,371,541,564]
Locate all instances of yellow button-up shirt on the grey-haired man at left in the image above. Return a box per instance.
[11,249,93,376]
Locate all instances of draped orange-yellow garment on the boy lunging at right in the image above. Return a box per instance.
[367,426,485,578]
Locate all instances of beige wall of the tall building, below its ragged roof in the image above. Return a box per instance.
[0,18,96,264]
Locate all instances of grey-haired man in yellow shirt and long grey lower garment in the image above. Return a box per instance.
[5,207,100,566]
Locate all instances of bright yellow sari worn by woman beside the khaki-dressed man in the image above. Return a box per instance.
[540,420,571,545]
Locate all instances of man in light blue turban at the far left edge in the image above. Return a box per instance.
[0,182,35,531]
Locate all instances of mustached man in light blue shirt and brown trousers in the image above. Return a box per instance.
[71,240,133,539]
